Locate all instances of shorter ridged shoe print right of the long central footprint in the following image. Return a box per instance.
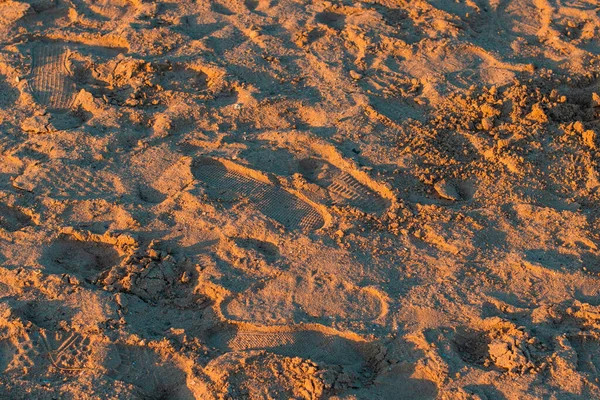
[300,158,387,212]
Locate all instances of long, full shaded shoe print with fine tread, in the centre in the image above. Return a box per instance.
[192,158,325,231]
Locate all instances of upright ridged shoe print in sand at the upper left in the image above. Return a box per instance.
[30,42,76,111]
